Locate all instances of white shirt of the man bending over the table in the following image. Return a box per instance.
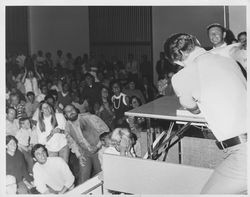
[172,51,247,141]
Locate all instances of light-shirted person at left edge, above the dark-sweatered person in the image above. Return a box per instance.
[6,107,19,136]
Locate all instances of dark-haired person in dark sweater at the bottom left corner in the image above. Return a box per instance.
[6,135,33,194]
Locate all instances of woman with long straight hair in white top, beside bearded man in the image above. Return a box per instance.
[34,101,69,162]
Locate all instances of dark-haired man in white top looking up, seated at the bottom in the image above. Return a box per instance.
[31,144,75,194]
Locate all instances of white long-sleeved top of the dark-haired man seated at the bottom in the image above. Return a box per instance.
[33,157,75,193]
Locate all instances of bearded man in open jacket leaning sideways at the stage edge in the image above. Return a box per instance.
[64,104,109,184]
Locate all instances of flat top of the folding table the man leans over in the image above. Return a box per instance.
[125,96,206,123]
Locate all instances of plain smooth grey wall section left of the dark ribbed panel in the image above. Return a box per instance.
[29,6,89,60]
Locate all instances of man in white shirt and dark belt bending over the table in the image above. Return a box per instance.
[164,33,247,194]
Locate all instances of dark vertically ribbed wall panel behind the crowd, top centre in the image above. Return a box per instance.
[89,6,152,75]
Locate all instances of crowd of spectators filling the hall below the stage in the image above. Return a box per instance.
[6,25,246,194]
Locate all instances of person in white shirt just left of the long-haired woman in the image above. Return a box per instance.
[16,118,37,173]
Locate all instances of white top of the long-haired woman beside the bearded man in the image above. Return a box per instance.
[37,113,67,152]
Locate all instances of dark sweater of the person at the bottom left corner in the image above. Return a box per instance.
[6,150,33,183]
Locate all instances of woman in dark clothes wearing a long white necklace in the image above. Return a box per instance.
[111,80,130,126]
